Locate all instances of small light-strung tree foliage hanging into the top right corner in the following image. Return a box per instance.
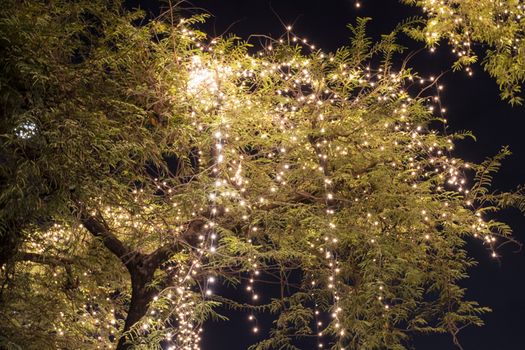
[403,0,525,104]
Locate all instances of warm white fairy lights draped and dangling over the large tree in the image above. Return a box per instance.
[12,8,524,350]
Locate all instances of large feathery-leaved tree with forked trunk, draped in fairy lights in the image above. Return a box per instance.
[0,1,525,349]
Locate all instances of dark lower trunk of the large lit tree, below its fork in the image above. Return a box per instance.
[116,255,156,350]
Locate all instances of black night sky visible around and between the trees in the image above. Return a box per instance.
[126,0,525,350]
